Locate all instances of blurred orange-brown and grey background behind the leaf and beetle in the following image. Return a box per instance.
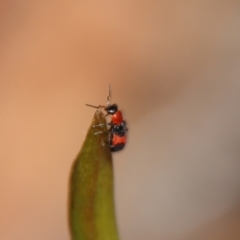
[0,0,240,240]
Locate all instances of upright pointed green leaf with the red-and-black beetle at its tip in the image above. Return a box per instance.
[69,110,119,240]
